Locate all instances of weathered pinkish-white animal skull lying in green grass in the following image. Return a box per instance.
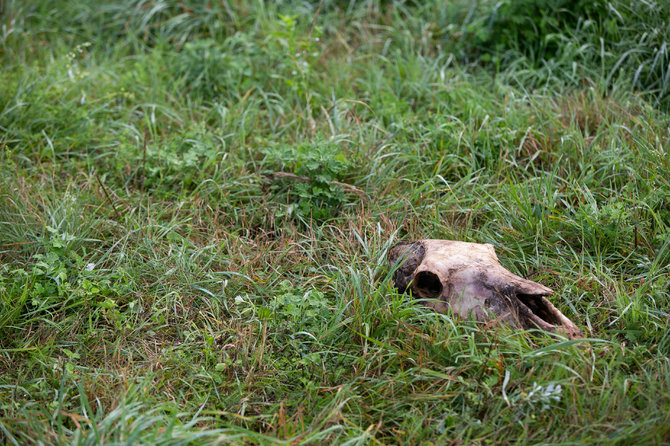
[388,240,582,339]
